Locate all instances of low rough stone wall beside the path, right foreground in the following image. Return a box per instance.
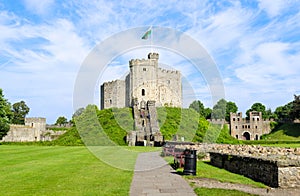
[176,144,300,188]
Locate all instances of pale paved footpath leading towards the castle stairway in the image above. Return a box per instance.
[130,152,196,196]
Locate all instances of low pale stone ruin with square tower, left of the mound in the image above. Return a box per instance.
[2,118,65,142]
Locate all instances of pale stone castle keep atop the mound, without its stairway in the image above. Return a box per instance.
[100,53,182,109]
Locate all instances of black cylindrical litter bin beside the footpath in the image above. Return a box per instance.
[183,149,197,176]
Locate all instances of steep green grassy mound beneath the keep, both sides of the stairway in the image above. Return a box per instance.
[1,105,239,146]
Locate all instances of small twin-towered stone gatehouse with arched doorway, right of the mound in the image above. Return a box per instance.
[230,111,271,140]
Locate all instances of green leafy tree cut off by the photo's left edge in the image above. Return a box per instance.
[0,89,12,139]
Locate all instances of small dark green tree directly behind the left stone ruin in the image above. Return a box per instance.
[12,101,30,125]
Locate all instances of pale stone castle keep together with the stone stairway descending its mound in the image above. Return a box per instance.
[101,53,182,146]
